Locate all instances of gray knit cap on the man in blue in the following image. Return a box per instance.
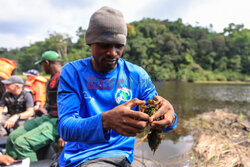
[85,6,127,45]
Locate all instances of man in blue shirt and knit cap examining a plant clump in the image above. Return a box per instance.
[57,7,177,167]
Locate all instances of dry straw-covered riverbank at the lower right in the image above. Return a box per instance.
[184,110,250,167]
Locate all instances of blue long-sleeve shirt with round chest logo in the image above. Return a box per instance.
[57,58,176,166]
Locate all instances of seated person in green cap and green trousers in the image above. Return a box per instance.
[6,51,64,162]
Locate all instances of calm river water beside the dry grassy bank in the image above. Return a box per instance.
[133,81,250,167]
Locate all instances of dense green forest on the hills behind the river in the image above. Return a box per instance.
[0,18,250,82]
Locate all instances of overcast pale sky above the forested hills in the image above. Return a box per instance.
[0,0,250,49]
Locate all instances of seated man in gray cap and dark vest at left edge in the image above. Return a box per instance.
[0,75,34,136]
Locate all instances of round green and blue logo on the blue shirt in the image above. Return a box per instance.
[115,88,132,105]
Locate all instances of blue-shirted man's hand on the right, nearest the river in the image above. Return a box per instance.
[149,96,175,131]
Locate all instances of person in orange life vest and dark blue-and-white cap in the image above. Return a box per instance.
[23,69,47,112]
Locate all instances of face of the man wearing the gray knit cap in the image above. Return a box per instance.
[91,43,124,72]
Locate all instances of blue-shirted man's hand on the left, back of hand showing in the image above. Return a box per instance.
[102,99,149,136]
